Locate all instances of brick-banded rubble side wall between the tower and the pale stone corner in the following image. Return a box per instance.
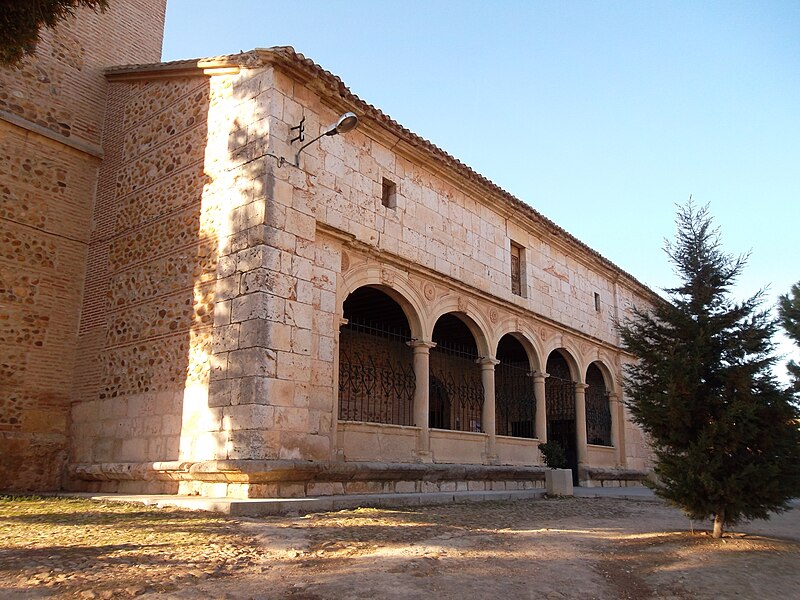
[65,72,224,491]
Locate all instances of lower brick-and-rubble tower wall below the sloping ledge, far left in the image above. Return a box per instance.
[0,110,97,491]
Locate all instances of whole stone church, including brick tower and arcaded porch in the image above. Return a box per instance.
[0,0,656,497]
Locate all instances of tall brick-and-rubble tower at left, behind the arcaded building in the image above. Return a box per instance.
[0,0,166,491]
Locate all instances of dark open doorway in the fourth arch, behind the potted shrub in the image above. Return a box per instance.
[545,350,578,485]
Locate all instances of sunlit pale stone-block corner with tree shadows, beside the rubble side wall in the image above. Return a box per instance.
[198,73,276,464]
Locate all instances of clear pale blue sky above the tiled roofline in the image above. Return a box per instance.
[163,0,800,376]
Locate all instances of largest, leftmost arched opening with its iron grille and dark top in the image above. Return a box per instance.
[339,287,415,425]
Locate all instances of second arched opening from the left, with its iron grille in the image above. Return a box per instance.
[428,314,483,432]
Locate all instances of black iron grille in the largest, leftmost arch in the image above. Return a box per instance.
[339,321,416,425]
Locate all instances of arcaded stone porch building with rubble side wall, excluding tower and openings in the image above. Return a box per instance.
[61,48,653,496]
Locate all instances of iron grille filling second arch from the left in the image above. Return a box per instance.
[429,345,484,431]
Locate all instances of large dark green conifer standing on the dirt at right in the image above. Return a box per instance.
[619,201,800,537]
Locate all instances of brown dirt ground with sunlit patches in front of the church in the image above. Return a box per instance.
[0,498,800,600]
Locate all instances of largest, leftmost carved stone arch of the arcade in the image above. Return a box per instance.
[337,263,430,339]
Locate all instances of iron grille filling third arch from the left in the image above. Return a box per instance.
[494,363,536,438]
